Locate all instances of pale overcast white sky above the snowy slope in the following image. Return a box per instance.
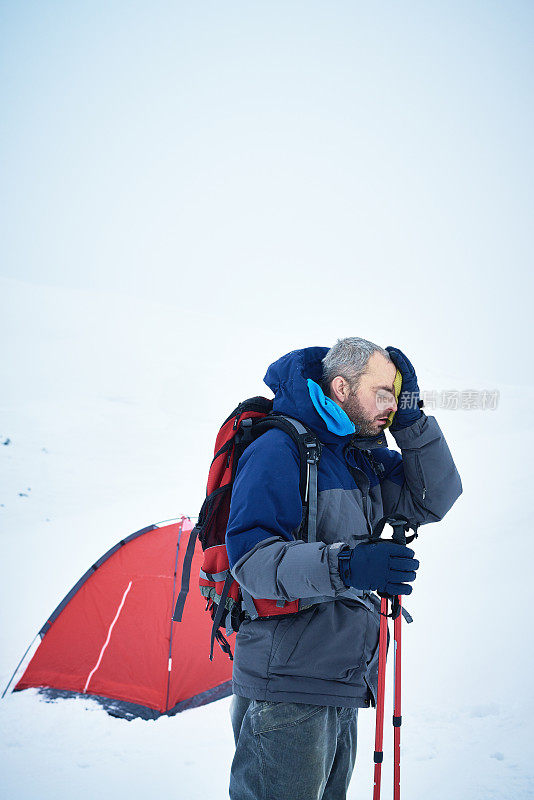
[0,0,534,388]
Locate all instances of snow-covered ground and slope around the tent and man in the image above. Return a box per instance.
[0,280,534,800]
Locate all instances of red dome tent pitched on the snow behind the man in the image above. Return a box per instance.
[14,518,232,719]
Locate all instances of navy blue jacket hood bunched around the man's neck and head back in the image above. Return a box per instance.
[264,347,383,446]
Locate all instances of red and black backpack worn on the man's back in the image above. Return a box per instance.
[172,397,321,660]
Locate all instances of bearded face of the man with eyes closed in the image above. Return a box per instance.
[343,353,397,436]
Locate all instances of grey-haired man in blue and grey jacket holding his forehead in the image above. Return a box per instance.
[226,337,462,800]
